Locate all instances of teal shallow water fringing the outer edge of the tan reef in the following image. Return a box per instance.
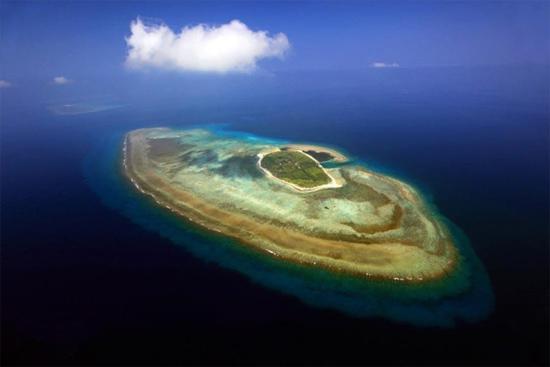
[84,125,493,327]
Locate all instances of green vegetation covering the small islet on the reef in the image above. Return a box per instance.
[261,150,331,188]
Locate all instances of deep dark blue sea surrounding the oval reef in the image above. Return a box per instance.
[0,68,550,364]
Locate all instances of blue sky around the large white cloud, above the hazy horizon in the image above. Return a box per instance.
[0,1,550,80]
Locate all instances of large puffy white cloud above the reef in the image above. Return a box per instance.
[126,18,290,73]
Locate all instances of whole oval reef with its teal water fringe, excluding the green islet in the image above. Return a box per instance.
[86,128,493,326]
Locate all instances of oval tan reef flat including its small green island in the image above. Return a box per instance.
[123,128,461,283]
